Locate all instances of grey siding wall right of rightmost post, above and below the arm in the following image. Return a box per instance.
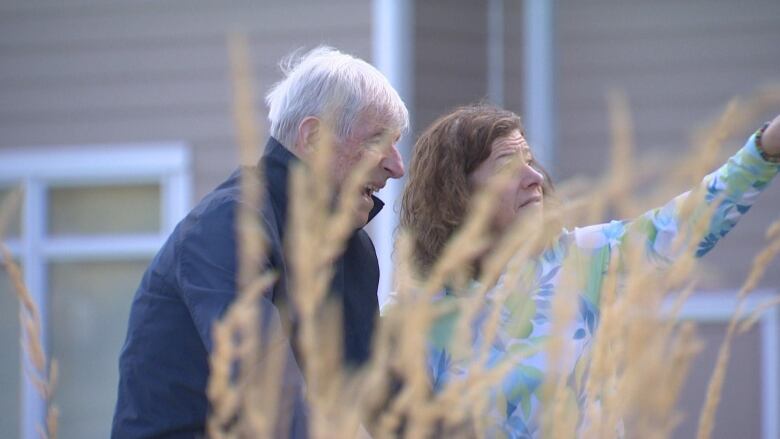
[554,0,780,438]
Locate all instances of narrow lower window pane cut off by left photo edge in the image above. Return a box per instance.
[0,265,21,437]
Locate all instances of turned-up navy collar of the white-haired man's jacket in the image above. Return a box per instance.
[260,137,385,224]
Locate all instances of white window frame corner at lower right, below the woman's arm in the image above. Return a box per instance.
[665,289,780,439]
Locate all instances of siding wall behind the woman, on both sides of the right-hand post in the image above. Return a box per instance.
[415,0,780,438]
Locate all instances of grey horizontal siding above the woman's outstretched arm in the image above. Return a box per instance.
[556,0,780,177]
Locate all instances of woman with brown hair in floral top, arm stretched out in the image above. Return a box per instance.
[401,105,780,437]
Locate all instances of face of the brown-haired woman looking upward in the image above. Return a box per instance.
[469,130,544,231]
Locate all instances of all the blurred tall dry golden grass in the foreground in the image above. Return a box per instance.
[2,36,780,438]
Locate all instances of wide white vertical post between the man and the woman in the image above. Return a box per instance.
[369,0,414,305]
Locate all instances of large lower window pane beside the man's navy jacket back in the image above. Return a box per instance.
[49,261,148,438]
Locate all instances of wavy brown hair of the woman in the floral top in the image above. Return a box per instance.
[400,104,553,272]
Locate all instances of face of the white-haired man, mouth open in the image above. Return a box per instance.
[333,117,404,227]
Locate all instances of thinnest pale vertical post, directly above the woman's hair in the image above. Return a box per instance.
[487,0,504,107]
